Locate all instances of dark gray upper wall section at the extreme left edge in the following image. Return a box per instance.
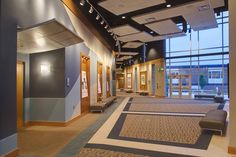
[0,1,16,141]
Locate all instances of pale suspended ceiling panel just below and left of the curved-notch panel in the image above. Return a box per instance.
[118,32,153,42]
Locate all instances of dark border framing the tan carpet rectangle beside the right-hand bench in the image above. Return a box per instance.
[108,113,212,150]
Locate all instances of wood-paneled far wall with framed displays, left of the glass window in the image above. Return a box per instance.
[124,58,166,97]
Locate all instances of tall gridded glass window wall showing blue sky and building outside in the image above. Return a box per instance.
[166,12,229,97]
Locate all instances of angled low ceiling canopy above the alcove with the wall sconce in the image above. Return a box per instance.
[17,19,83,53]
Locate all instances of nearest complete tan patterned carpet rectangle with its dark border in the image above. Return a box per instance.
[108,113,212,149]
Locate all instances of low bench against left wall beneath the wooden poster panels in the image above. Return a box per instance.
[90,96,116,112]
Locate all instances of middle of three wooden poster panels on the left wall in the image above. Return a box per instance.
[97,62,102,101]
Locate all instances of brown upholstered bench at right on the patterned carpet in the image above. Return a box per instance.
[199,110,227,136]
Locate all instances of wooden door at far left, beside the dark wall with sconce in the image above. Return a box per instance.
[16,62,24,129]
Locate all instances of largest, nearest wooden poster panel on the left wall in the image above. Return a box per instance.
[80,55,90,114]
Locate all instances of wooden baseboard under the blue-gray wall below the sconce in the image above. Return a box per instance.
[25,112,88,127]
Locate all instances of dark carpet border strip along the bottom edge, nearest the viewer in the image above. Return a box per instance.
[84,144,196,157]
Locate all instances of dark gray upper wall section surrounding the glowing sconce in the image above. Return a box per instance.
[30,48,65,98]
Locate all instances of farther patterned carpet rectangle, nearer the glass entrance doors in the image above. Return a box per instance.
[124,98,224,114]
